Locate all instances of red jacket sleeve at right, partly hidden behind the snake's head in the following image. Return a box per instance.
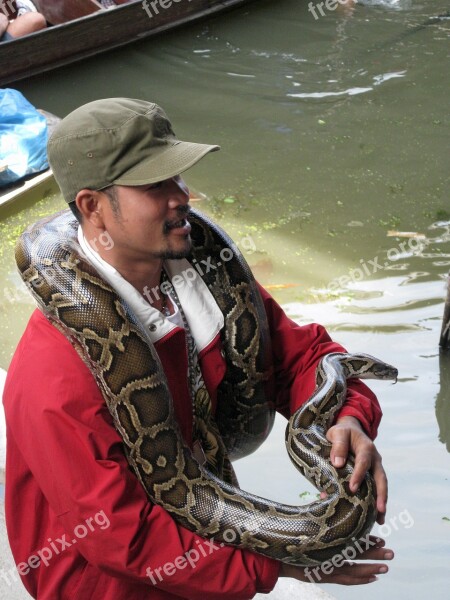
[260,287,382,439]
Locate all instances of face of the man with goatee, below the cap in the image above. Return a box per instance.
[103,176,191,263]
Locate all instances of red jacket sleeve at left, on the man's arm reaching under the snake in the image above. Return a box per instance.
[7,312,279,600]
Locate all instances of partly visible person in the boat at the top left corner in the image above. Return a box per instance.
[0,0,47,42]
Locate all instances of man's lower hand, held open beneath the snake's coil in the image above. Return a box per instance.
[280,536,394,585]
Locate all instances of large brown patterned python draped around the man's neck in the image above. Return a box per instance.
[16,210,397,565]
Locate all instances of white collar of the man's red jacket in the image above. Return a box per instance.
[78,227,224,352]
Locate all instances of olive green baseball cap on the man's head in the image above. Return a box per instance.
[47,98,220,203]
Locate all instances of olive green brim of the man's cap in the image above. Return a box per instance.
[111,140,220,186]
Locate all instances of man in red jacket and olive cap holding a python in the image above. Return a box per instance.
[4,98,393,600]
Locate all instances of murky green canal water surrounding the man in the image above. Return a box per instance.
[0,0,450,600]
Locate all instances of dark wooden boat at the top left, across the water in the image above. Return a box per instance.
[0,0,253,86]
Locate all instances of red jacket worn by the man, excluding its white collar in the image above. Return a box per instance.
[4,291,381,600]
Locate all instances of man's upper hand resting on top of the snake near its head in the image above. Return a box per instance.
[327,417,388,525]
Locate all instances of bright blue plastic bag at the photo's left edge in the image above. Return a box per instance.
[0,89,48,186]
